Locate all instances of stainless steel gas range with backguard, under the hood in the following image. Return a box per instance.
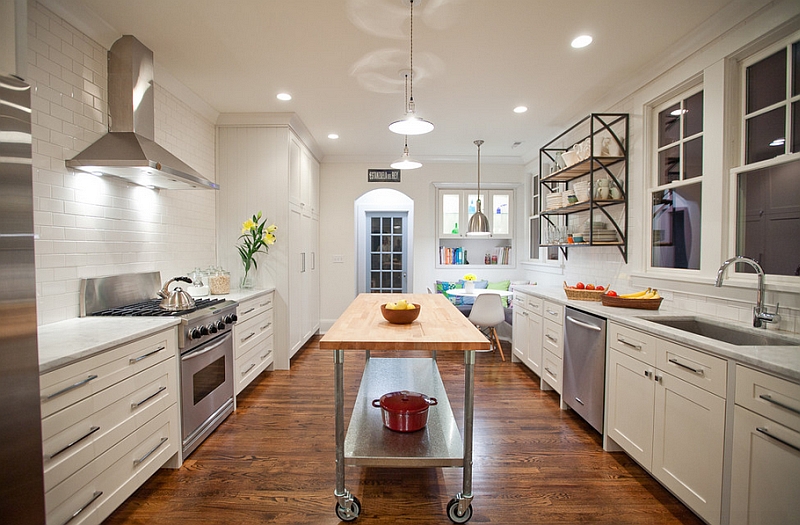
[80,272,238,458]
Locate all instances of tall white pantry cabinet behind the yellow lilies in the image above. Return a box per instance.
[217,114,320,370]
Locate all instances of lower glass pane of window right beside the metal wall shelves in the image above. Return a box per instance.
[651,182,702,270]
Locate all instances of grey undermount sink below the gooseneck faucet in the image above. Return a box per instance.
[641,317,800,346]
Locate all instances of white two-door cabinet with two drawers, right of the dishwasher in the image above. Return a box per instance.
[606,323,727,524]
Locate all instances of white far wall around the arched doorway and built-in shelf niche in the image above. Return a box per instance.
[320,162,527,331]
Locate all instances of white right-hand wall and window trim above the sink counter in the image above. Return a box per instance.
[526,1,800,332]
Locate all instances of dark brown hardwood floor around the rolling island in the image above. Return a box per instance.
[105,338,702,525]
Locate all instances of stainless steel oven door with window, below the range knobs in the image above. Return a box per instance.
[181,331,234,458]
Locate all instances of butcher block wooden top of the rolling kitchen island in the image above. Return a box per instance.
[319,294,491,352]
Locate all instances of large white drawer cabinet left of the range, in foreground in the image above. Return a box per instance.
[40,328,181,524]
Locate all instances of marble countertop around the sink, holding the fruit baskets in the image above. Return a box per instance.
[514,285,800,383]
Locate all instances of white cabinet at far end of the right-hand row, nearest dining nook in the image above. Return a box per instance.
[512,292,543,377]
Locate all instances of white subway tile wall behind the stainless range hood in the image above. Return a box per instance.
[28,2,216,324]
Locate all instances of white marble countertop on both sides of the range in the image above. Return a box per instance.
[38,288,274,374]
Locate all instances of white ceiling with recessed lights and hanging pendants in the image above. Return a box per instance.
[44,0,744,164]
